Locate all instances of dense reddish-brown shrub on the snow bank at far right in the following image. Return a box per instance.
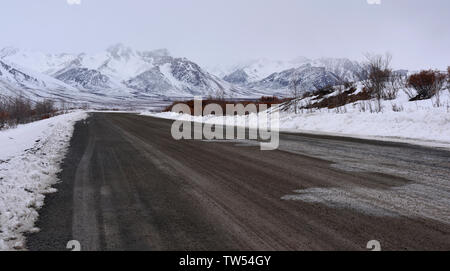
[408,70,446,100]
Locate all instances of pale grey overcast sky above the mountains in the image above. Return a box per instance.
[0,0,450,69]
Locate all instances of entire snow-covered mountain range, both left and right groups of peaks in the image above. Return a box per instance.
[0,44,370,105]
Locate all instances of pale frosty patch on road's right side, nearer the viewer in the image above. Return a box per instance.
[282,183,450,224]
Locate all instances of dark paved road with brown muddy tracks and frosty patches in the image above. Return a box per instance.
[27,113,450,250]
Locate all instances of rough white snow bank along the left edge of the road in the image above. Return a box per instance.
[0,111,87,250]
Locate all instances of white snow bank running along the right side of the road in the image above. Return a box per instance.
[142,90,450,148]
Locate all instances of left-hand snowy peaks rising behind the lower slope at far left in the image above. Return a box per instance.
[0,44,246,98]
